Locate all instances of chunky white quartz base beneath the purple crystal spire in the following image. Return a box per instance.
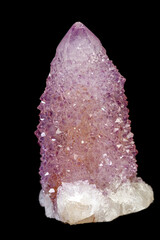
[39,178,153,224]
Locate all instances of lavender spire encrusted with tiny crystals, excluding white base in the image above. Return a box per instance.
[36,22,154,223]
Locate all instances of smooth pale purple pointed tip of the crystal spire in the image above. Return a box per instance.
[56,22,106,62]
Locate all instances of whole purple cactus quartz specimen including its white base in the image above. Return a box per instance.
[36,22,153,224]
